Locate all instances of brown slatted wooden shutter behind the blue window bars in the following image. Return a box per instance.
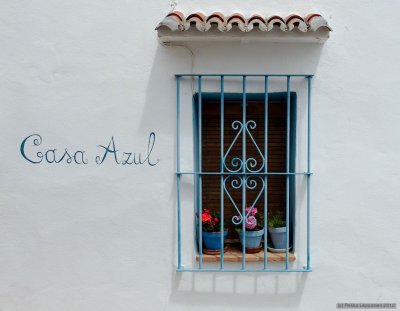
[201,100,286,238]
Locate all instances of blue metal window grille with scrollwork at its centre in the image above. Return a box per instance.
[176,75,312,272]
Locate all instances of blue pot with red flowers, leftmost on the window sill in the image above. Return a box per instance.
[201,208,228,251]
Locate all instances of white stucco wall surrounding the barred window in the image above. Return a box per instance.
[0,0,400,311]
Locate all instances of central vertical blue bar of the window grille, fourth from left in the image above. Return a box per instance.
[241,76,247,270]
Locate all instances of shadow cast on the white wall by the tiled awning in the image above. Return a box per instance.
[140,43,323,137]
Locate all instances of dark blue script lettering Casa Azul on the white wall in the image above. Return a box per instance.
[20,132,160,166]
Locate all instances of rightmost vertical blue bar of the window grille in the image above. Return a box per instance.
[307,76,312,270]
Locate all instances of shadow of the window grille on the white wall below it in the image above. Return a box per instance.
[169,273,308,310]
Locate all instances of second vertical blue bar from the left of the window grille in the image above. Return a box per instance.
[197,76,203,269]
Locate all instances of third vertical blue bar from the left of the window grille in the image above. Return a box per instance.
[220,76,225,270]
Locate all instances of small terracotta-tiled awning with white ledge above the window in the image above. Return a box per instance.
[156,11,332,44]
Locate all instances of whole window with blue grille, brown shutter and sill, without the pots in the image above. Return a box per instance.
[177,75,311,272]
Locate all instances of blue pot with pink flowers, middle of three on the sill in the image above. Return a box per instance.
[236,207,264,252]
